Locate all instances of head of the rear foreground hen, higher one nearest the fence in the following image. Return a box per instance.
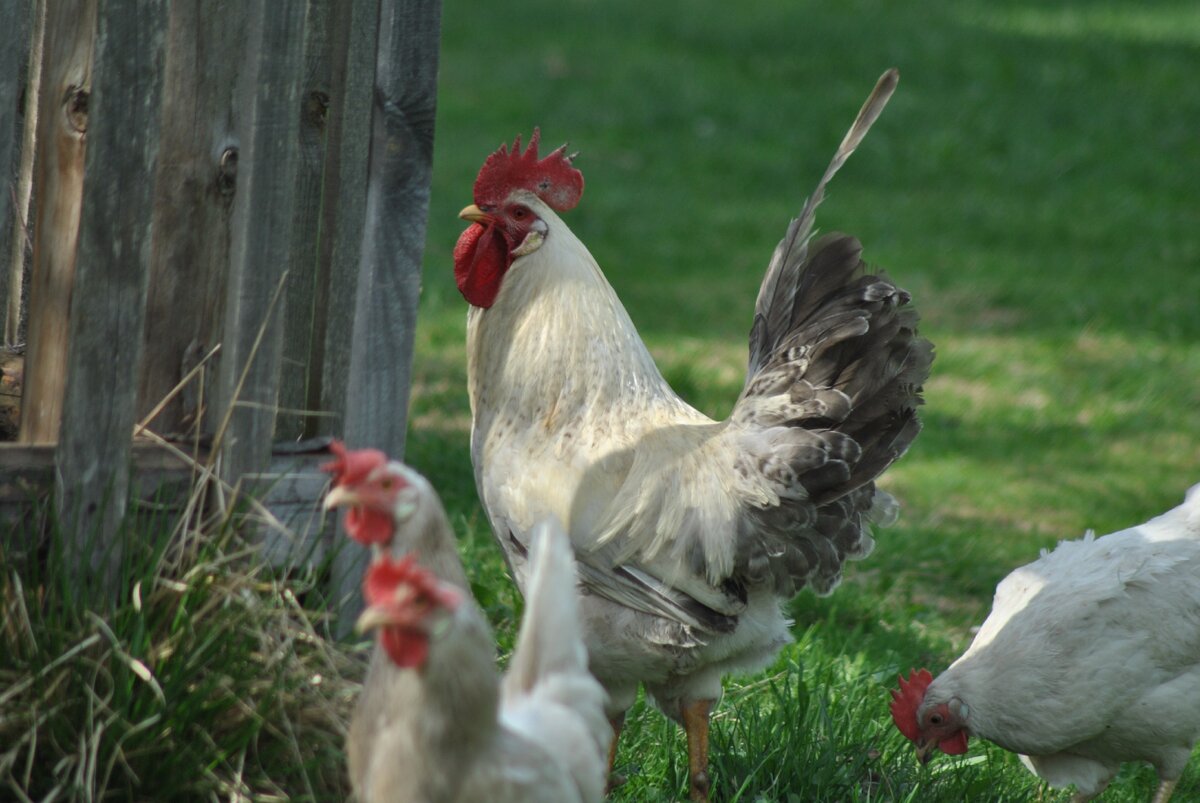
[320,441,418,546]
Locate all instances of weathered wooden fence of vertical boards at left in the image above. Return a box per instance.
[0,0,440,628]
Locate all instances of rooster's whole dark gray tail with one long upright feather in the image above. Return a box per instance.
[734,70,932,593]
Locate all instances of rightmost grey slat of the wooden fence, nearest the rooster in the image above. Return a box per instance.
[332,0,442,635]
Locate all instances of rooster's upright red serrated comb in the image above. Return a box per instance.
[475,128,583,212]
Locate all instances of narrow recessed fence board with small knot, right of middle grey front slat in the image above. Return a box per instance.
[275,0,338,441]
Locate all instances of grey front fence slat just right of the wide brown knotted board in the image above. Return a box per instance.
[216,0,305,490]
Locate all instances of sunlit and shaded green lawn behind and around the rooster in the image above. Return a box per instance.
[408,0,1200,801]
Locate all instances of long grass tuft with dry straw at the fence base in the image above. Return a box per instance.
[0,496,365,803]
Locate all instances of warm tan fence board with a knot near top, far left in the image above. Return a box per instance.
[19,0,96,443]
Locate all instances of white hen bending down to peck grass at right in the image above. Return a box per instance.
[892,485,1200,803]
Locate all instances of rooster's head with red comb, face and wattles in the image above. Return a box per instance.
[454,128,583,308]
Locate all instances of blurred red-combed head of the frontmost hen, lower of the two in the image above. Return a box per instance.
[355,555,462,669]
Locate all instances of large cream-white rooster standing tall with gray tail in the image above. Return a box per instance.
[455,71,932,799]
